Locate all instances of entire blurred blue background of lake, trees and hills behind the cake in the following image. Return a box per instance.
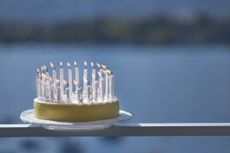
[0,0,230,153]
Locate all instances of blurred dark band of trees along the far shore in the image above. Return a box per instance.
[0,15,230,44]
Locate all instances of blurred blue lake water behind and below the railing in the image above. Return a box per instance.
[0,44,230,153]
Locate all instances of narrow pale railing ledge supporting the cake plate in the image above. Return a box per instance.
[0,123,230,137]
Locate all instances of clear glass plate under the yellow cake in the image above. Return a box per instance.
[20,109,132,131]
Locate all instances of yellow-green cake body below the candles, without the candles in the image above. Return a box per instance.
[34,99,119,122]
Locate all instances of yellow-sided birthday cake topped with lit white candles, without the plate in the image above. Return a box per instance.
[34,61,119,122]
